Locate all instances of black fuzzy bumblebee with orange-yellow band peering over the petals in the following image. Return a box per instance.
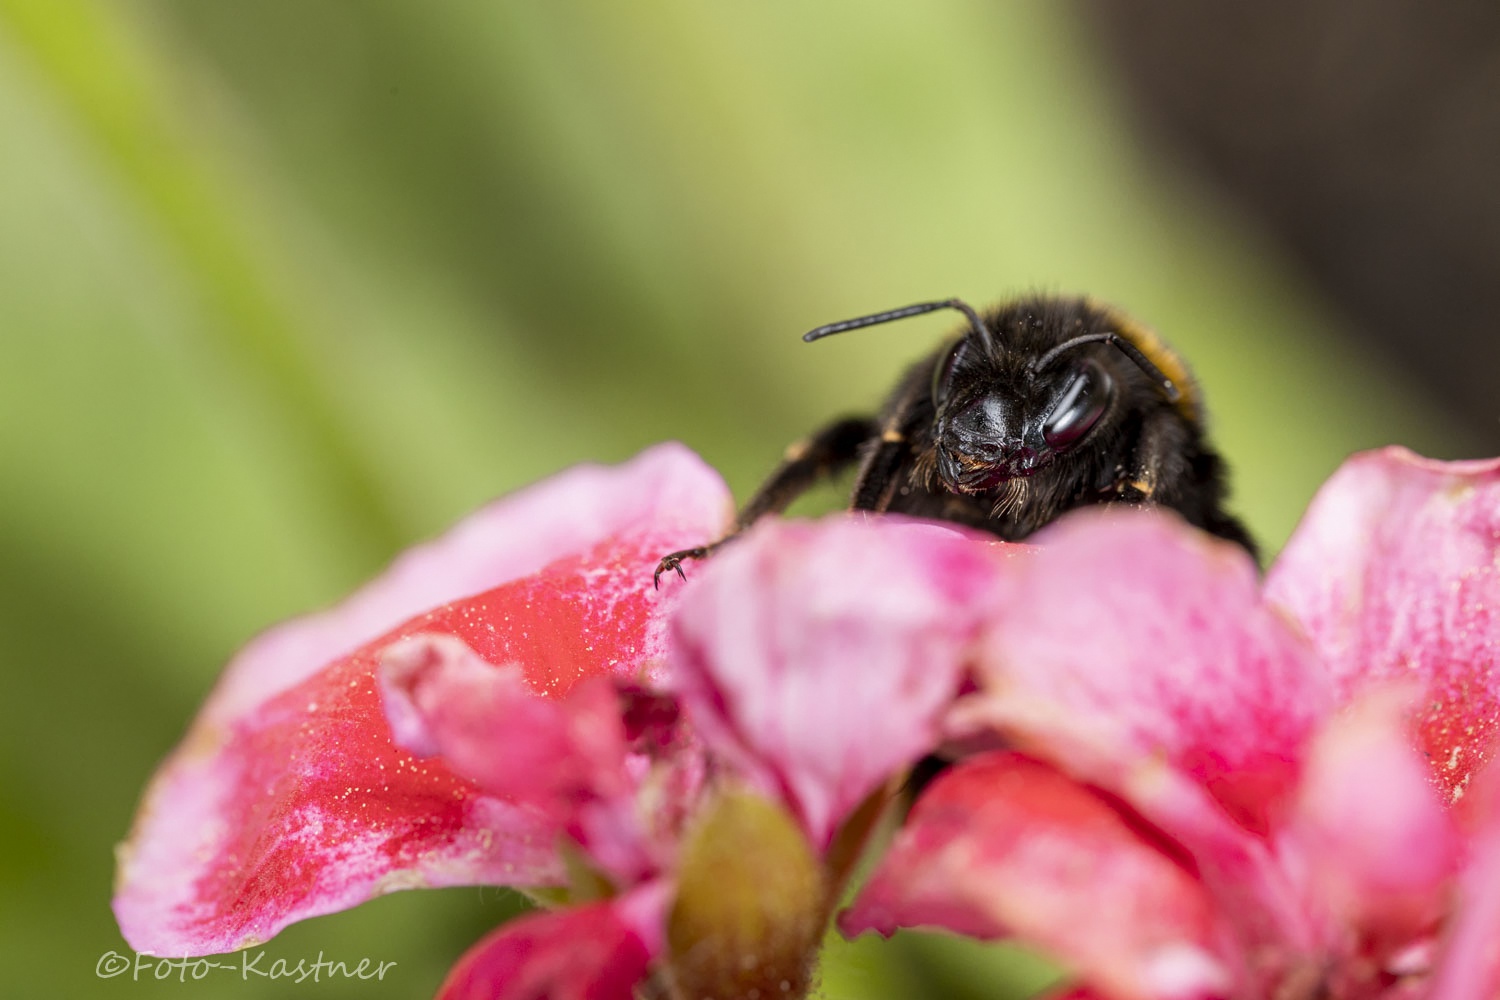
[656,297,1257,585]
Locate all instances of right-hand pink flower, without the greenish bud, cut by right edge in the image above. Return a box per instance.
[842,450,1500,999]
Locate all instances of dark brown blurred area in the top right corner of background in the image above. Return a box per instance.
[1089,0,1500,453]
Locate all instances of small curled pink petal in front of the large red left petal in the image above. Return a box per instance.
[380,636,653,883]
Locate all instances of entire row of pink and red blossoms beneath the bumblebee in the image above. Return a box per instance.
[116,447,1500,999]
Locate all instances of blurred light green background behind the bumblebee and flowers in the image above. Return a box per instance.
[0,0,1467,999]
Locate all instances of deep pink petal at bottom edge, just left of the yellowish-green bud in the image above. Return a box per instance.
[438,898,665,1000]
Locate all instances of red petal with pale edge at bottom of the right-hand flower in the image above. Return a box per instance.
[839,753,1230,997]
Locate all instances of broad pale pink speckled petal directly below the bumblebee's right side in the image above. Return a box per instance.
[956,510,1332,835]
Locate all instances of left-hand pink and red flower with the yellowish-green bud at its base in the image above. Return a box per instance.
[114,447,996,999]
